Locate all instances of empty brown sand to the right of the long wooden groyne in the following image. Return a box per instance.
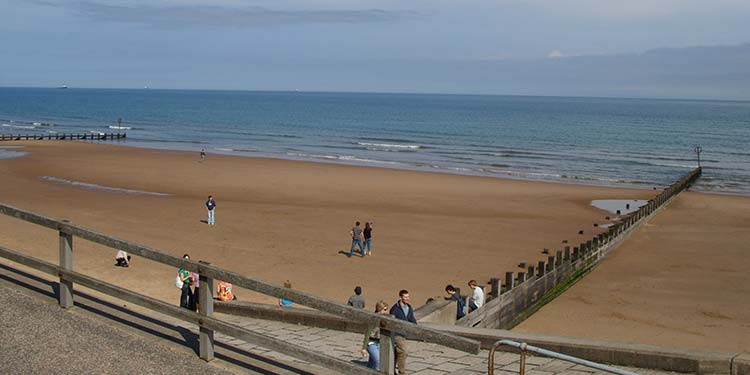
[515,192,750,352]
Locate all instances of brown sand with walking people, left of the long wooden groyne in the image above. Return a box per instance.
[0,142,652,306]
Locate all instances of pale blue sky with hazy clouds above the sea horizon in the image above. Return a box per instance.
[0,0,750,99]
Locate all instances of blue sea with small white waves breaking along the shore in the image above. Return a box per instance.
[0,88,750,195]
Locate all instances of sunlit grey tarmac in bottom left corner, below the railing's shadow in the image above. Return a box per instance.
[0,282,229,374]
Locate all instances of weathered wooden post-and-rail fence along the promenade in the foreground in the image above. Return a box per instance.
[0,204,480,374]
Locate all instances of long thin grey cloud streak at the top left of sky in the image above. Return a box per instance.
[29,0,418,28]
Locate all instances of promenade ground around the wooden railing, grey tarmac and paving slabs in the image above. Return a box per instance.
[0,262,680,375]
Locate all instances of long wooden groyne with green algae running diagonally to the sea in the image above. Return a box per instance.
[456,167,701,329]
